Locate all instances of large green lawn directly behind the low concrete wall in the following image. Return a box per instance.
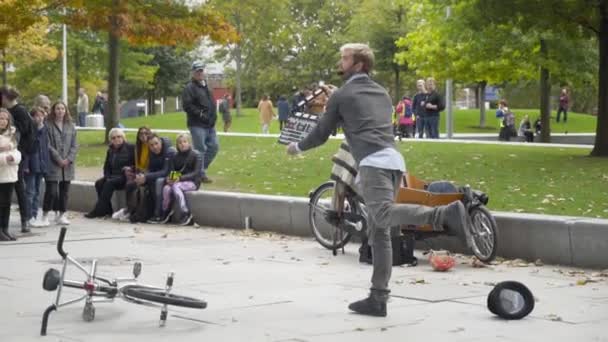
[77,132,608,218]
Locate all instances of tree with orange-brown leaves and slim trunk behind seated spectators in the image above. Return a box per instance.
[49,0,238,142]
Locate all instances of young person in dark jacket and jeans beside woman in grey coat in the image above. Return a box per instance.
[23,107,51,227]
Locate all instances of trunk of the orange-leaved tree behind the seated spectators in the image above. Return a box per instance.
[104,10,120,143]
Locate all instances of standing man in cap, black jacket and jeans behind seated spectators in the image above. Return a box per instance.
[182,61,219,183]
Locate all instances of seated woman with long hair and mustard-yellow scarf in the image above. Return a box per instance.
[112,126,151,221]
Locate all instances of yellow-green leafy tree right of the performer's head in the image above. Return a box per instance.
[397,0,535,127]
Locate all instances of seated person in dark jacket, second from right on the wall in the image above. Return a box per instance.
[144,133,177,223]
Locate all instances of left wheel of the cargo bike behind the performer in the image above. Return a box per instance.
[308,181,357,250]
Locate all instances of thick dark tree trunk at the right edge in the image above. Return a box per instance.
[591,0,608,157]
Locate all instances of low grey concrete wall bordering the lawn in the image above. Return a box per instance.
[63,181,608,269]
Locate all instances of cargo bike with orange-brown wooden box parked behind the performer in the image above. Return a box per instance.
[309,143,498,263]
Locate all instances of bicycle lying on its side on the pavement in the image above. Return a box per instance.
[40,227,207,336]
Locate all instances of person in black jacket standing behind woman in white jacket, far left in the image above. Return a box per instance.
[0,87,34,233]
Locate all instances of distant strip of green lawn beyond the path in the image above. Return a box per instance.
[121,108,597,133]
